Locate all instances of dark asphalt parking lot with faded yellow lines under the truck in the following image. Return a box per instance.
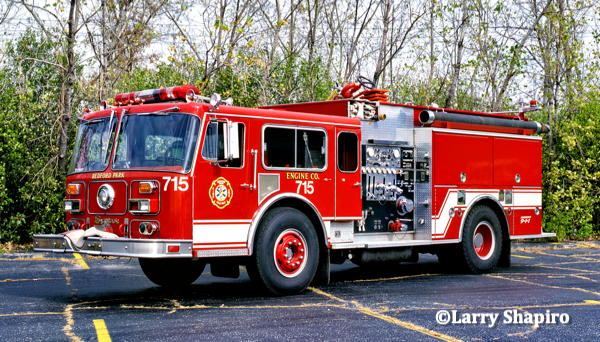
[0,242,600,341]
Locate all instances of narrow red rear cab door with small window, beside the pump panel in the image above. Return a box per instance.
[335,127,362,221]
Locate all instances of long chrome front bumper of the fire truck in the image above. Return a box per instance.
[33,235,192,258]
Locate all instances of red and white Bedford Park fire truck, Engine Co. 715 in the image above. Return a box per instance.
[34,77,554,295]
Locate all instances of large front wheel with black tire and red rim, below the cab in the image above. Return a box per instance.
[248,208,319,295]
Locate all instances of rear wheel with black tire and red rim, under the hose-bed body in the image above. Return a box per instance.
[462,205,502,274]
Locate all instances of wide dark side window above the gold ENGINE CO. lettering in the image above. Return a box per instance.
[263,127,327,169]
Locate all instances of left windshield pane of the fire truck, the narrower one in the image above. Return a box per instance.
[69,116,118,173]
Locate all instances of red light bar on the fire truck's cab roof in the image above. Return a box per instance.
[115,85,200,106]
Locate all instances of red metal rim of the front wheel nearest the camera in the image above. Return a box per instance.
[273,229,308,278]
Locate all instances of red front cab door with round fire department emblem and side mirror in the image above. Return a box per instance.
[193,114,258,256]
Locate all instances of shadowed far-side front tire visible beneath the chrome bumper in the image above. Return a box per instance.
[140,258,206,287]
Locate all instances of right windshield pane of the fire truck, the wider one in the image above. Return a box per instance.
[112,113,200,173]
